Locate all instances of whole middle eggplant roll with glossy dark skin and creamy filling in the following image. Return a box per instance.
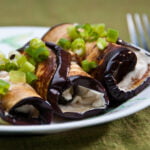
[35,42,109,119]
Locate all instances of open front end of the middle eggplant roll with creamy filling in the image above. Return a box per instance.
[49,59,109,119]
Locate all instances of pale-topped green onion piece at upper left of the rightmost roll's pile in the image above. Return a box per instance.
[67,26,80,40]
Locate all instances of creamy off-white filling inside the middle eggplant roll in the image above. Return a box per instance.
[59,86,106,113]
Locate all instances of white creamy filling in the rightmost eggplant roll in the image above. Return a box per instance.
[117,51,150,91]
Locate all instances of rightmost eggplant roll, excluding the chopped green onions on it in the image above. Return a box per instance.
[42,24,150,104]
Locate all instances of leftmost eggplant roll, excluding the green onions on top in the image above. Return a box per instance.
[0,71,52,125]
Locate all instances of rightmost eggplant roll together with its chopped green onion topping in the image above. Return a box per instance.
[42,24,150,104]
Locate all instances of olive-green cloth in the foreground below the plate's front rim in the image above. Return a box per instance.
[0,108,150,150]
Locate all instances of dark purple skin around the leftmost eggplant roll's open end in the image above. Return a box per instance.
[0,97,52,125]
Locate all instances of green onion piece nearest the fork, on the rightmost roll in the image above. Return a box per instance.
[106,29,119,43]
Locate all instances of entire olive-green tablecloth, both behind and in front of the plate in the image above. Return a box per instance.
[0,0,150,150]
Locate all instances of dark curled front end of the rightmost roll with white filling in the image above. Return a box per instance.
[93,43,150,104]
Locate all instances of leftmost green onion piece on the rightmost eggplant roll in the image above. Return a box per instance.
[57,38,71,50]
